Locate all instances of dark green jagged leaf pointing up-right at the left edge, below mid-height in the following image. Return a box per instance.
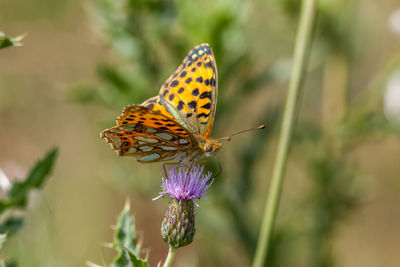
[0,148,58,214]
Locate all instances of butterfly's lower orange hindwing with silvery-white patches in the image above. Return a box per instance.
[100,105,198,162]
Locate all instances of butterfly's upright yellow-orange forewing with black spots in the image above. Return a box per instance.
[157,44,218,138]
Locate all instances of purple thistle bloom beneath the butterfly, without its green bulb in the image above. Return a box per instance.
[154,165,214,206]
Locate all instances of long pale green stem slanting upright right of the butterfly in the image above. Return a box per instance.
[252,0,317,267]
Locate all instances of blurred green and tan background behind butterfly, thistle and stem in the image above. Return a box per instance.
[0,0,400,267]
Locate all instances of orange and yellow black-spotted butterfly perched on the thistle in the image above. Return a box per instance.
[100,44,225,163]
